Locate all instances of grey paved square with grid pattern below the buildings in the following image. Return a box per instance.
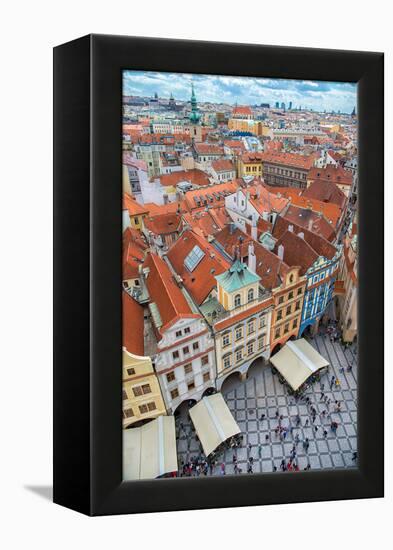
[177,336,357,475]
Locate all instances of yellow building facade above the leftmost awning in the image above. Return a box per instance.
[123,347,166,428]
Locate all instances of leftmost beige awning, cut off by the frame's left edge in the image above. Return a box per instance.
[123,416,178,480]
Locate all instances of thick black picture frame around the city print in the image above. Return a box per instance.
[54,35,384,515]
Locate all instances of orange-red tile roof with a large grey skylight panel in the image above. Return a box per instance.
[167,231,230,305]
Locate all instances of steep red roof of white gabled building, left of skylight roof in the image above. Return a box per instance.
[143,252,199,334]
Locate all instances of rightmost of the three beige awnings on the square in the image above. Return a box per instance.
[270,338,329,391]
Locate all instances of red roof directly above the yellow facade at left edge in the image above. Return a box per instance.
[122,290,144,356]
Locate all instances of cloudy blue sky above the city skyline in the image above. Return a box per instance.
[123,71,356,113]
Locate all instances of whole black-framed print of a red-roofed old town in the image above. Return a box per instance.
[54,35,383,515]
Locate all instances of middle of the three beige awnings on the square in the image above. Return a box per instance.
[190,393,241,456]
